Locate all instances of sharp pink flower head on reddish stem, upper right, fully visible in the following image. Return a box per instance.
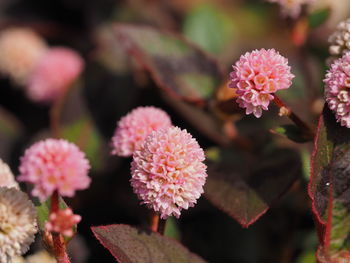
[229,49,294,118]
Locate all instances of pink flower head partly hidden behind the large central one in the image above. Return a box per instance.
[112,107,171,157]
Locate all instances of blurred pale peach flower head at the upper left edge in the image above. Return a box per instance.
[0,28,47,85]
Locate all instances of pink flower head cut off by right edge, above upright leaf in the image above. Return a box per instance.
[324,52,350,128]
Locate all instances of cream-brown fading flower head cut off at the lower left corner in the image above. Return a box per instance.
[0,187,37,263]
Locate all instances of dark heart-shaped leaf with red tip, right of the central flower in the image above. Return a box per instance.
[205,146,301,227]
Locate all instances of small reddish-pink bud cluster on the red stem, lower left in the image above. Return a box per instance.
[45,208,81,237]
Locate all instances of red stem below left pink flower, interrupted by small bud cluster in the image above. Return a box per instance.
[50,191,70,263]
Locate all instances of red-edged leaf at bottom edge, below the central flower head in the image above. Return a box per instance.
[91,225,205,263]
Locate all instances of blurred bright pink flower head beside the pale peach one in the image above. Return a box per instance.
[27,47,84,102]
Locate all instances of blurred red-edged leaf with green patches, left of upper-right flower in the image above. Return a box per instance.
[114,24,222,102]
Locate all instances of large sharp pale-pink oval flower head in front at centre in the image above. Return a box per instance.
[130,127,207,219]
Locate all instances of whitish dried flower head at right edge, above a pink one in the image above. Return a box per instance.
[328,18,350,56]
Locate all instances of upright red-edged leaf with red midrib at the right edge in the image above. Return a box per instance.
[309,107,350,262]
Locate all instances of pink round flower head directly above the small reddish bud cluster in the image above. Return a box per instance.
[18,139,90,201]
